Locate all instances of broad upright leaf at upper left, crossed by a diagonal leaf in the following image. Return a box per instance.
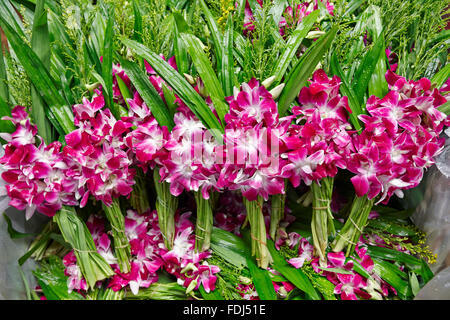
[31,0,53,144]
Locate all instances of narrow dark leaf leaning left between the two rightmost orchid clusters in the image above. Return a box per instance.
[330,52,363,131]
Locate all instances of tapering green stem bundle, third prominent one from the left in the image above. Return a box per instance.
[153,168,178,250]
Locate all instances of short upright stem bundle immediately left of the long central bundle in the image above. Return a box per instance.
[194,191,213,251]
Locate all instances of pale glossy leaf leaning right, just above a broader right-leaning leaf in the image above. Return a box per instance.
[273,10,319,86]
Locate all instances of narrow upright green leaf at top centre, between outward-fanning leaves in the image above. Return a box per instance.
[220,14,234,97]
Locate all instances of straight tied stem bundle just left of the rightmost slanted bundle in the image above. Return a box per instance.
[311,177,335,261]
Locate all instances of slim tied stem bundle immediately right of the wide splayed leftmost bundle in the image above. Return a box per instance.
[103,198,131,273]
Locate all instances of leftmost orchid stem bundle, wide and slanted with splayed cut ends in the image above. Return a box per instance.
[53,207,114,288]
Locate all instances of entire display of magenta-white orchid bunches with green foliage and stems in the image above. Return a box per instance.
[0,0,450,300]
